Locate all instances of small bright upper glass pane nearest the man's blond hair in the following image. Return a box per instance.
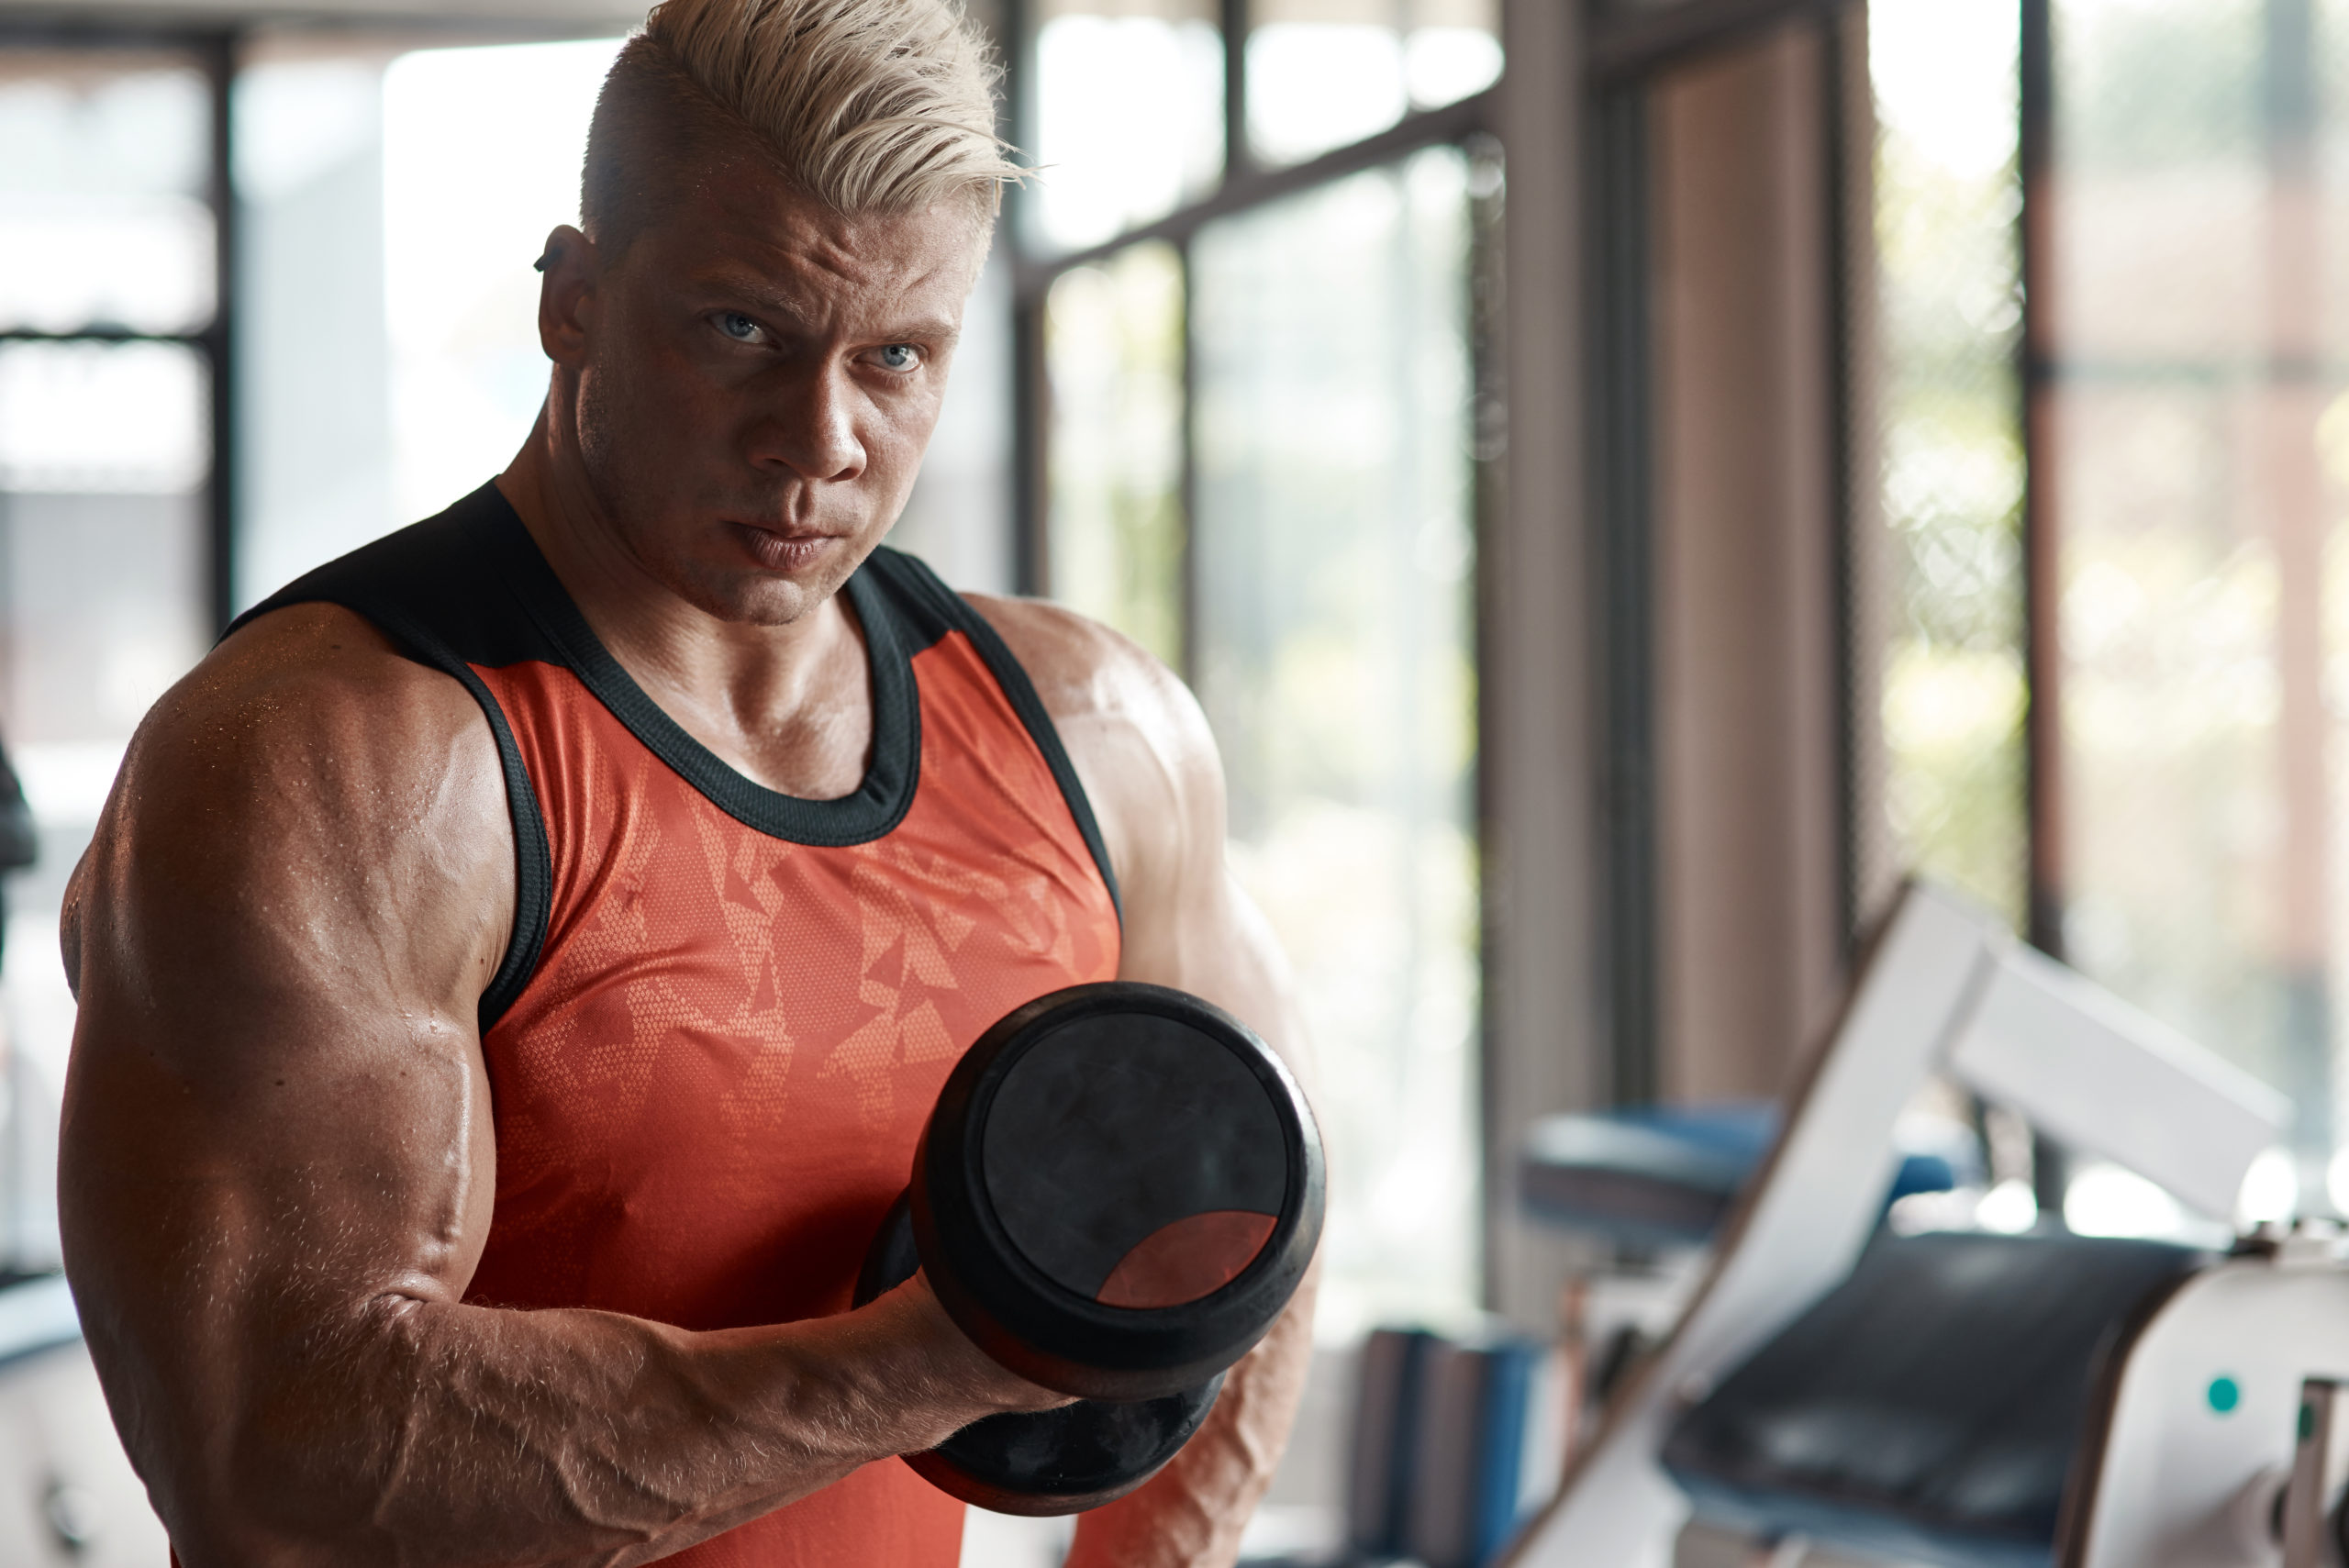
[1029,0,1224,249]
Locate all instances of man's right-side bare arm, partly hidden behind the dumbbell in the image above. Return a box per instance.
[974,598,1313,1568]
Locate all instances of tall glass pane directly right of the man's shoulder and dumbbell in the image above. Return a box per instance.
[1193,148,1477,1331]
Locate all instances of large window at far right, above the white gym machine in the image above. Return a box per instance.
[1870,0,2349,1228]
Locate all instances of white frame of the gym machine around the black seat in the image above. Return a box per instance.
[1503,887,2349,1568]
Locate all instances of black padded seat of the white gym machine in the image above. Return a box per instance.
[1663,1232,2210,1568]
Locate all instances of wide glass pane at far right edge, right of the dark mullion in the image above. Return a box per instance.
[2043,0,2349,1207]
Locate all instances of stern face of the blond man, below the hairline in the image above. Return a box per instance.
[550,155,986,625]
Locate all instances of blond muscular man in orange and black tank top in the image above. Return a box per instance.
[61,0,1308,1568]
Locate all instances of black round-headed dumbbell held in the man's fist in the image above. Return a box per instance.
[855,981,1322,1514]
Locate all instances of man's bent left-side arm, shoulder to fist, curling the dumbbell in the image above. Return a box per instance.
[59,606,1062,1568]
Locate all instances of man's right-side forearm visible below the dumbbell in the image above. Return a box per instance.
[1069,1277,1313,1568]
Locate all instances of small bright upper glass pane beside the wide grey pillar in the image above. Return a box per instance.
[1247,0,1501,164]
